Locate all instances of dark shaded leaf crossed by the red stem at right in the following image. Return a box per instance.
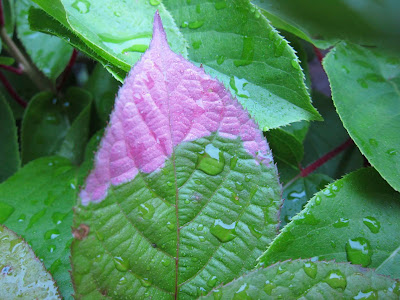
[302,91,363,179]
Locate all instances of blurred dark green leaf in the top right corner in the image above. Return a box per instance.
[253,0,400,50]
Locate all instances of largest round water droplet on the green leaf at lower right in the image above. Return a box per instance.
[346,237,372,267]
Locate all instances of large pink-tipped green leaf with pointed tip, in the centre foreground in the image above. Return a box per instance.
[71,14,281,299]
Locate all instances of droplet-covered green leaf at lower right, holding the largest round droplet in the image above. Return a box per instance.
[260,168,400,278]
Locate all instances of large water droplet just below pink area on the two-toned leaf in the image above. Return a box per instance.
[196,144,225,175]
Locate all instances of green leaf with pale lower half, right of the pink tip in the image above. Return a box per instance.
[164,0,321,131]
